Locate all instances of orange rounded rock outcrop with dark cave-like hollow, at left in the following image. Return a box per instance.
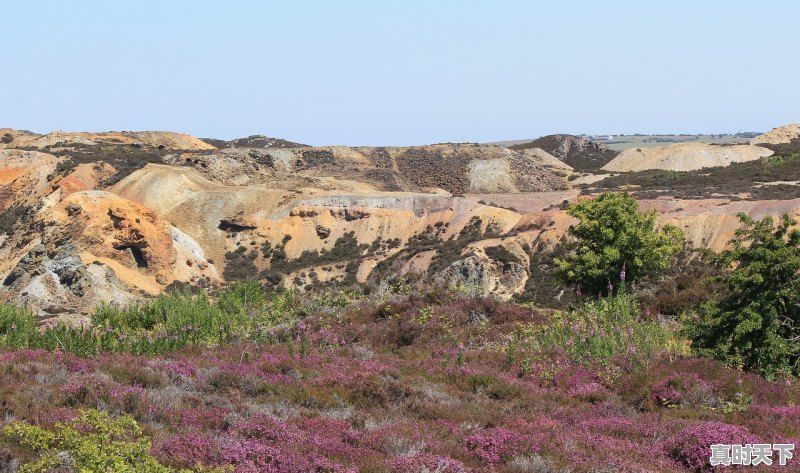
[0,190,216,315]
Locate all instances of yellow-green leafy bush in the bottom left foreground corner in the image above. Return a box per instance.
[2,410,172,473]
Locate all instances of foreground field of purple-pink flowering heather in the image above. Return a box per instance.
[0,291,800,472]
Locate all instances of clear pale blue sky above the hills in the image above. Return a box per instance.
[0,0,800,145]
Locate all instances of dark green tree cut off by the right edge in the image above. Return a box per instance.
[686,214,800,378]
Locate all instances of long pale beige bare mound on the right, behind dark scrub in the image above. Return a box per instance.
[602,143,773,172]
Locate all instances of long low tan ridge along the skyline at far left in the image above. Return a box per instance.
[0,129,214,150]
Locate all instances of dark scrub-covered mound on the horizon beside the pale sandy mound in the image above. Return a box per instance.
[509,135,618,171]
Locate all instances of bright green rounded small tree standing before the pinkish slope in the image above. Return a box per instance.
[555,192,684,294]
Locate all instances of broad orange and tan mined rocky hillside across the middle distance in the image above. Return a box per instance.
[0,125,800,317]
